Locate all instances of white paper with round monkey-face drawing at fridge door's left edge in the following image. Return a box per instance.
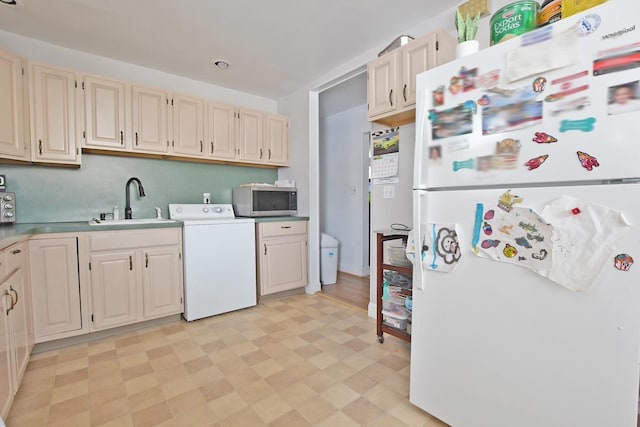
[406,223,462,273]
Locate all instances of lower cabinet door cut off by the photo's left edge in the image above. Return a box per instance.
[0,283,15,419]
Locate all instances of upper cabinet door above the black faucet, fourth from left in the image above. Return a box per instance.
[131,86,169,153]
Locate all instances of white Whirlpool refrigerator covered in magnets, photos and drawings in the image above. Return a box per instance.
[408,0,640,427]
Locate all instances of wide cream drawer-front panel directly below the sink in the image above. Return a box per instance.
[88,228,182,252]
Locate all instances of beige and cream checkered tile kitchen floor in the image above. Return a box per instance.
[7,295,445,427]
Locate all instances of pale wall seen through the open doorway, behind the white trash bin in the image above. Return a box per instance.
[320,104,371,276]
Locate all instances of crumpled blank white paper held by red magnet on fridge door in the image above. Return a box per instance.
[542,196,631,291]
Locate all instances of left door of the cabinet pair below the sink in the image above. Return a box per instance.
[89,251,138,331]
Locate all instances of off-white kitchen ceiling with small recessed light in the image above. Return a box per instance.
[0,0,453,100]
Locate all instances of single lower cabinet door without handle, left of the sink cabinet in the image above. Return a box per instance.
[29,237,82,342]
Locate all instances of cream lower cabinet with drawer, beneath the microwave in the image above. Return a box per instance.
[256,221,308,295]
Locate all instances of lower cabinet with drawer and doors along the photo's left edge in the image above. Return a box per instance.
[0,243,33,417]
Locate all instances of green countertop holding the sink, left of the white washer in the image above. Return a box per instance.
[0,221,182,249]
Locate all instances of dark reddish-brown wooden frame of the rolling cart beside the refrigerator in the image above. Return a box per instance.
[376,233,413,343]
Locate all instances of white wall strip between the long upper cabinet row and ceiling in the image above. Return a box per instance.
[0,30,278,112]
